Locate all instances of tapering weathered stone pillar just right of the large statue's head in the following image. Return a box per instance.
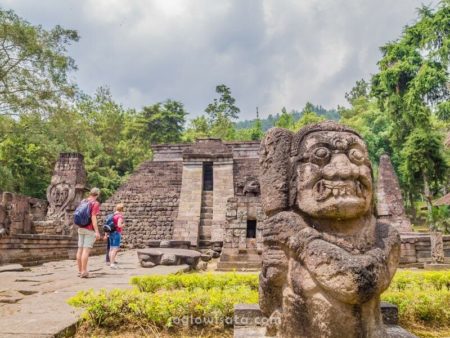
[377,155,412,232]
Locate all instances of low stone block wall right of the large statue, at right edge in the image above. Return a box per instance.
[400,233,450,267]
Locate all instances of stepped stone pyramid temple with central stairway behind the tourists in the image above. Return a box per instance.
[102,138,265,269]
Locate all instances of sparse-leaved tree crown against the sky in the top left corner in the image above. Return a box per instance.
[0,9,79,114]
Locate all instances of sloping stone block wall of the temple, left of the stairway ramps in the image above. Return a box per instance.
[101,161,183,248]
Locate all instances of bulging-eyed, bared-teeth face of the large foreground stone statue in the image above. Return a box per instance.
[296,131,372,219]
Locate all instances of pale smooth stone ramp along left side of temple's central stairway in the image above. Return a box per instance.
[173,160,203,246]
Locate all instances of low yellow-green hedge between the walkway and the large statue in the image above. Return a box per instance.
[69,273,258,328]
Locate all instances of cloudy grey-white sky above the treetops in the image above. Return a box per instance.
[0,0,436,119]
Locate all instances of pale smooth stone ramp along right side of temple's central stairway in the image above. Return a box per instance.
[211,158,234,243]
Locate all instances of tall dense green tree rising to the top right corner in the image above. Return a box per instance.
[372,0,450,213]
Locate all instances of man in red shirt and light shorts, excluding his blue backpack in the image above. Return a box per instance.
[77,188,100,278]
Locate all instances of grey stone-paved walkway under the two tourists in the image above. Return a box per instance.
[0,250,187,338]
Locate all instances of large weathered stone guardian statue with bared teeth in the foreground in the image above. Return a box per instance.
[259,121,400,338]
